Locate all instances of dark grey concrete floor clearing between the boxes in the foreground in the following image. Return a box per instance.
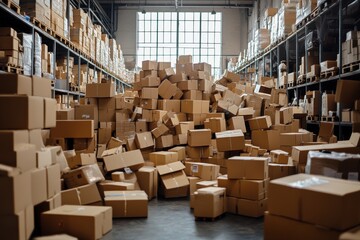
[103,199,263,240]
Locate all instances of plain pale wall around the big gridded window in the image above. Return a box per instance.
[115,8,248,68]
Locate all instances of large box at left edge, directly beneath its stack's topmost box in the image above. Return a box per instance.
[0,95,44,129]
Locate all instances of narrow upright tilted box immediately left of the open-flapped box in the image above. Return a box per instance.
[136,166,158,200]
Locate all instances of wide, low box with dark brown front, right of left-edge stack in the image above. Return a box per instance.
[50,120,94,138]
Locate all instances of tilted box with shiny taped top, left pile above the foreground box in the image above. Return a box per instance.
[63,164,105,188]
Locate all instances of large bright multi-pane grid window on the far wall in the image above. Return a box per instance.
[137,12,222,76]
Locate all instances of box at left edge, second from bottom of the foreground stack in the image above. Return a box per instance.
[0,164,32,215]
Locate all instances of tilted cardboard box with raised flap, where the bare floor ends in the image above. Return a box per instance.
[156,162,189,198]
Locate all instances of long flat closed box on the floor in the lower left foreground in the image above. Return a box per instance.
[41,205,112,239]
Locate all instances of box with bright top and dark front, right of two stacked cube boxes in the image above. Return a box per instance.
[215,130,245,152]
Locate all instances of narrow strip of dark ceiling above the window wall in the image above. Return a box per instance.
[98,0,256,9]
